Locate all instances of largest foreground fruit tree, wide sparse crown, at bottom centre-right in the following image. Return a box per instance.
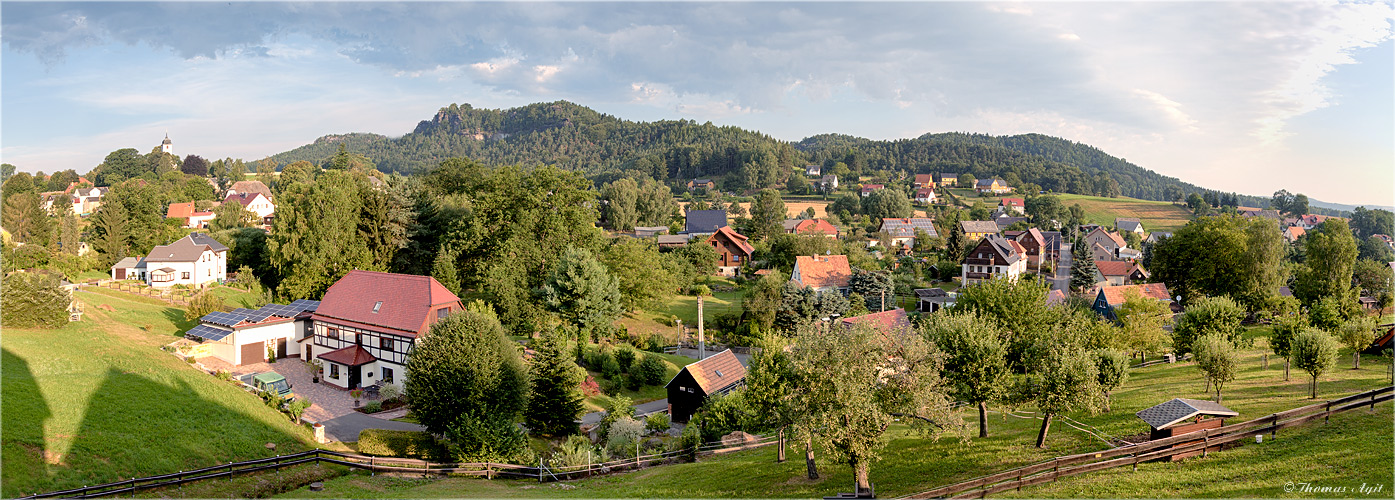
[791,325,957,494]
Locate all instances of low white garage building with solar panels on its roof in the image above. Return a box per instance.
[184,300,319,366]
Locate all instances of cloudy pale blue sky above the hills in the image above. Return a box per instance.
[0,1,1395,205]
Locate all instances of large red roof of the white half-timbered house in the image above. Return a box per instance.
[314,270,463,337]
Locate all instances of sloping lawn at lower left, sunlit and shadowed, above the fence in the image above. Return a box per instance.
[0,291,312,497]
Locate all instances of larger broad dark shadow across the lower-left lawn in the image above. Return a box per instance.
[49,369,311,490]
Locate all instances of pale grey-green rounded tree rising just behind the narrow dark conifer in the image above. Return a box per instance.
[541,247,622,332]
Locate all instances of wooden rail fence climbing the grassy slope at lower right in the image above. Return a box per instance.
[904,387,1395,499]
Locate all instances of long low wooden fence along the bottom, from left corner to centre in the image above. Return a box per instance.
[20,436,778,500]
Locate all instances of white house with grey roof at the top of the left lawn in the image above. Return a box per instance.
[112,233,227,288]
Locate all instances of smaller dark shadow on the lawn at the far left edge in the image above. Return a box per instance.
[0,349,53,499]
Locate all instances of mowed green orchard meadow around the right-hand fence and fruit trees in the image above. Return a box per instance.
[277,328,1395,497]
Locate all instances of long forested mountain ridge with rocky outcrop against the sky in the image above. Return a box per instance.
[262,101,1349,215]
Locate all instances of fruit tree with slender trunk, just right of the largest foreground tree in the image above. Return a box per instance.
[922,313,1011,437]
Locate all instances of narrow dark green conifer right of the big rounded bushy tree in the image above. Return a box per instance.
[525,334,586,436]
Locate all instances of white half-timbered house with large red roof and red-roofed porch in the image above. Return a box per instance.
[311,270,463,390]
